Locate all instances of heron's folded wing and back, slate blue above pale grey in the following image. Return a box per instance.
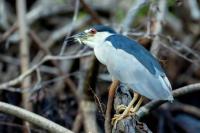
[103,37,173,100]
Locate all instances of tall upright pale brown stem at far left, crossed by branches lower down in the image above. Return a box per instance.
[17,0,32,130]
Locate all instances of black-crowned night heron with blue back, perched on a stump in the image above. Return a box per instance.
[67,25,173,127]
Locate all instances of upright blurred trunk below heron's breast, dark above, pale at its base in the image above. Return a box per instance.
[79,56,99,133]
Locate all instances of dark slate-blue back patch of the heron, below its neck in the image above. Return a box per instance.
[106,34,165,76]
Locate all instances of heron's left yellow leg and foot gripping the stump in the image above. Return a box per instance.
[112,93,142,127]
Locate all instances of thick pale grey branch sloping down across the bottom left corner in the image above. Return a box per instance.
[0,102,72,133]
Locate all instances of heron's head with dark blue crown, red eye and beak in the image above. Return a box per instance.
[71,25,116,48]
